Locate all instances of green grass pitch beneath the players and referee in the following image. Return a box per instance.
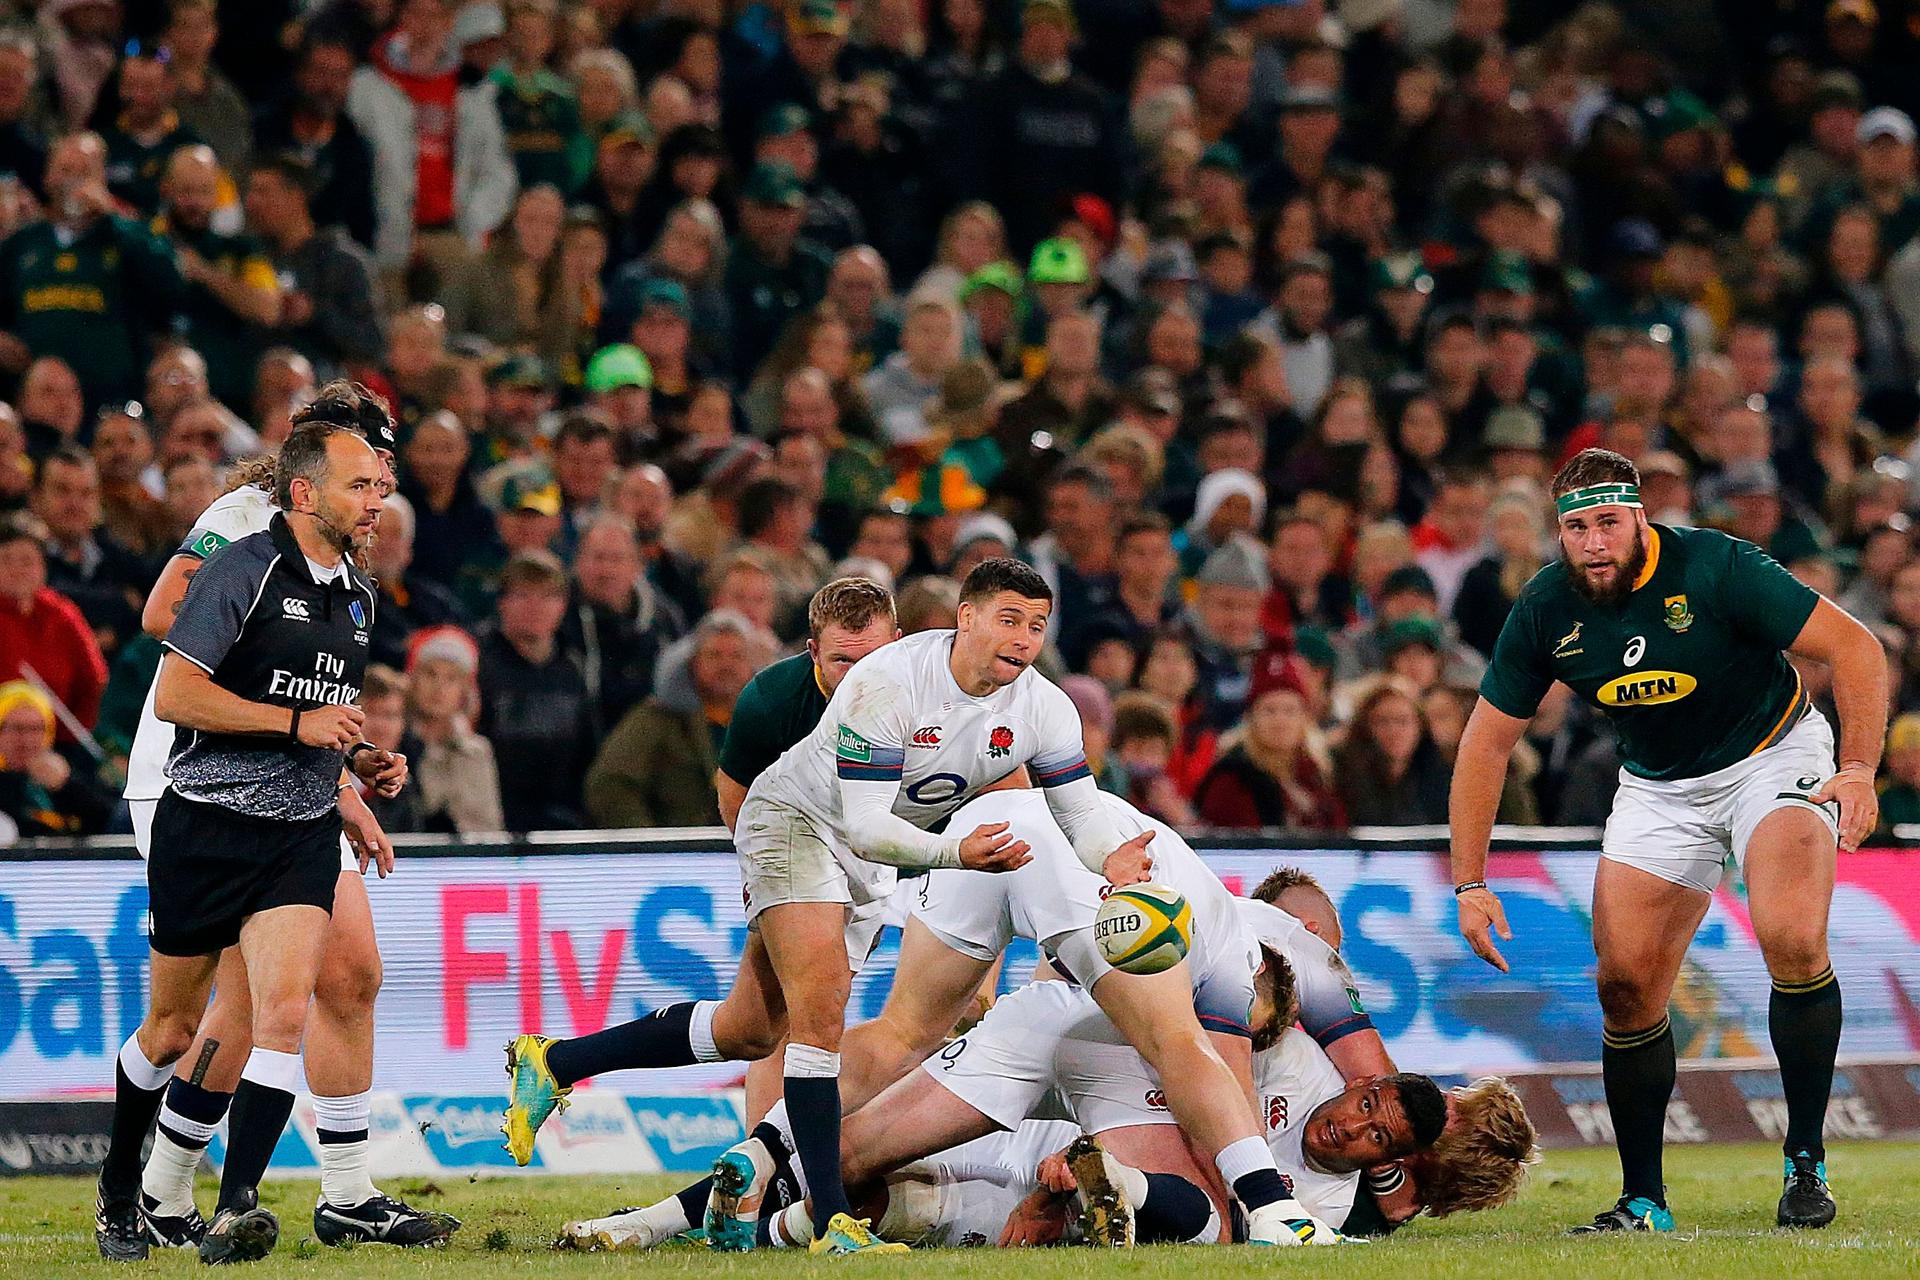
[0,1142,1920,1280]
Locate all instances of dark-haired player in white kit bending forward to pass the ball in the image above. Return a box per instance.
[714,560,1167,1253]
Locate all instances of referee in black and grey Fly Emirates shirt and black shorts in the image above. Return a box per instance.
[94,424,407,1263]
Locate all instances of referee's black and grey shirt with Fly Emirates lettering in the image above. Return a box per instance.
[165,514,376,821]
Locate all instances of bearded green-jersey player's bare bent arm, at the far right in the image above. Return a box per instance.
[1789,599,1887,854]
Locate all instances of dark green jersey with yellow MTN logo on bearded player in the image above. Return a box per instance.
[1480,526,1820,781]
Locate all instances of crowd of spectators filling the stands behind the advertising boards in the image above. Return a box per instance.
[0,0,1920,835]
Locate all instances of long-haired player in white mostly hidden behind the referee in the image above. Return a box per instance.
[125,382,459,1247]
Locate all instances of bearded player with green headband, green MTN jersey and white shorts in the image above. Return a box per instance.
[1452,449,1887,1232]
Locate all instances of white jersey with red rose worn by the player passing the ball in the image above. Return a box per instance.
[749,631,1089,842]
